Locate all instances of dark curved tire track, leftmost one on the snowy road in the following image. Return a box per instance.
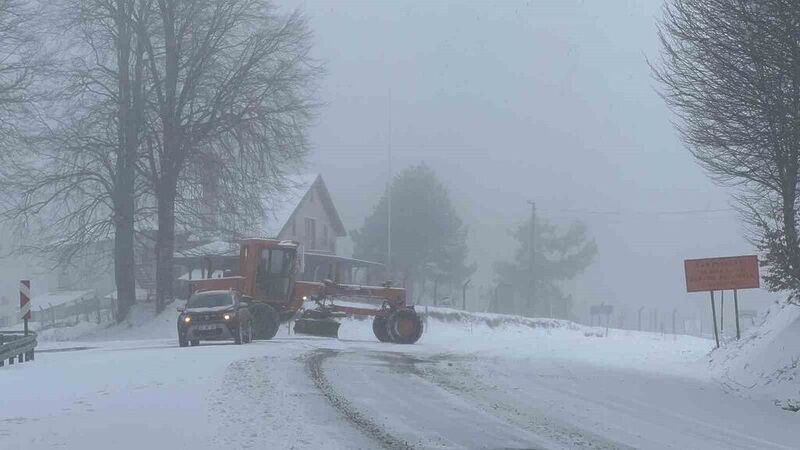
[305,349,414,450]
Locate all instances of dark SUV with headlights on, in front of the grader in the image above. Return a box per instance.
[178,290,253,347]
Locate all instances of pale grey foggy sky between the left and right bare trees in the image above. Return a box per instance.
[280,0,775,324]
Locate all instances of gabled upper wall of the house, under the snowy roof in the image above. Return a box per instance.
[278,184,336,254]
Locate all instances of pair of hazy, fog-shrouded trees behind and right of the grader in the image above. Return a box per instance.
[350,164,597,318]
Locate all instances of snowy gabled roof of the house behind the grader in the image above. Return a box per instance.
[264,174,347,237]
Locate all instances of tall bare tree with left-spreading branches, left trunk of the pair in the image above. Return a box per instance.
[3,0,149,320]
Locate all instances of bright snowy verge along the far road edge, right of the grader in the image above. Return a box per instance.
[339,308,714,380]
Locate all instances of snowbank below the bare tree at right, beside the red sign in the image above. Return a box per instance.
[711,303,800,411]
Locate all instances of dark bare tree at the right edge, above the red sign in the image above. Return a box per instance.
[653,0,800,300]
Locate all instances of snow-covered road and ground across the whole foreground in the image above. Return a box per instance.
[0,316,800,450]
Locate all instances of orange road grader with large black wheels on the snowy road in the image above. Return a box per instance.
[192,239,422,344]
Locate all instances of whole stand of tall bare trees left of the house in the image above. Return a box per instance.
[0,0,322,320]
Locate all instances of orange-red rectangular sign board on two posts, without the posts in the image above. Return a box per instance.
[683,255,761,292]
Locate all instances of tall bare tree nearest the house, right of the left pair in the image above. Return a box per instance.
[140,0,320,309]
